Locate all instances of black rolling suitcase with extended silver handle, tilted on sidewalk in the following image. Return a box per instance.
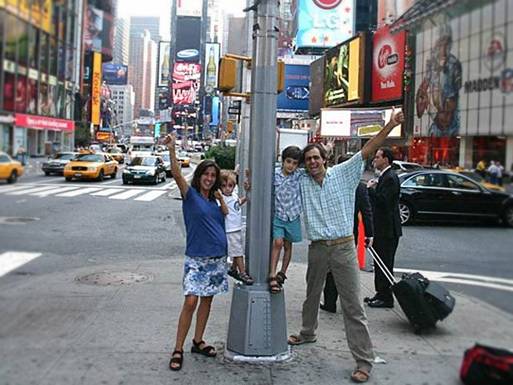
[368,247,455,334]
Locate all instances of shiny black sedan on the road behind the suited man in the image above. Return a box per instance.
[399,170,513,227]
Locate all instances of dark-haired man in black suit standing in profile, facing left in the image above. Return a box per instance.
[364,148,402,308]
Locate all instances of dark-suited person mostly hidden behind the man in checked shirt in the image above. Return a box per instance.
[320,155,374,313]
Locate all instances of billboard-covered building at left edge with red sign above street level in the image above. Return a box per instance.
[0,0,84,156]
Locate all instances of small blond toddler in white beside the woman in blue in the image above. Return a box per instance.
[221,170,254,285]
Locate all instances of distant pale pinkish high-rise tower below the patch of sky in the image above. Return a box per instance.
[128,30,157,118]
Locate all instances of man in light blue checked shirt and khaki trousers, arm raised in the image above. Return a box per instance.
[288,106,404,382]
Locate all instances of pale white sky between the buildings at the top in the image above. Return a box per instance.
[118,0,246,40]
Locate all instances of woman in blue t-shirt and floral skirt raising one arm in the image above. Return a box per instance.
[164,135,228,370]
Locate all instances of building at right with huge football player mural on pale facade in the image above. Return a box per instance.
[392,0,513,170]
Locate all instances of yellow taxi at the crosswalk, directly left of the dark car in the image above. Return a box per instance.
[64,151,118,182]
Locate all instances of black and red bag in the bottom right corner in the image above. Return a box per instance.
[460,344,513,385]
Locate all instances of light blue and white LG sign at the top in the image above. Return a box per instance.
[296,0,355,48]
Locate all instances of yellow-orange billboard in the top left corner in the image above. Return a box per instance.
[0,0,54,33]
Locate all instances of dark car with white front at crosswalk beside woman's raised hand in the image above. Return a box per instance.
[123,156,166,184]
